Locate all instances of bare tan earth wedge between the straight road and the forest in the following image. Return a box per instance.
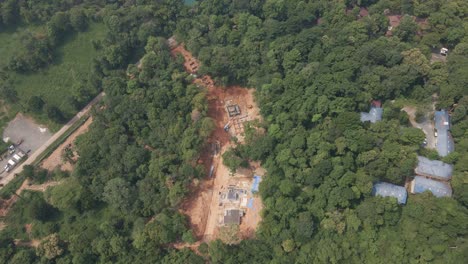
[41,117,93,171]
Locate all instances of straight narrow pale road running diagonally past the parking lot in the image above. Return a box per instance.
[0,92,105,189]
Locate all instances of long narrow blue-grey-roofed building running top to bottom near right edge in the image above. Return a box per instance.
[434,110,455,157]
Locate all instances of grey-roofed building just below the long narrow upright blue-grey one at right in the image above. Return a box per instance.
[415,156,453,181]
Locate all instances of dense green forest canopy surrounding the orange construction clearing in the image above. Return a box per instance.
[0,0,468,263]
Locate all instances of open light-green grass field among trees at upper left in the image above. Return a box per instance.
[0,23,106,131]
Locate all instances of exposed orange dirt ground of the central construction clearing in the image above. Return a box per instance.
[172,45,262,243]
